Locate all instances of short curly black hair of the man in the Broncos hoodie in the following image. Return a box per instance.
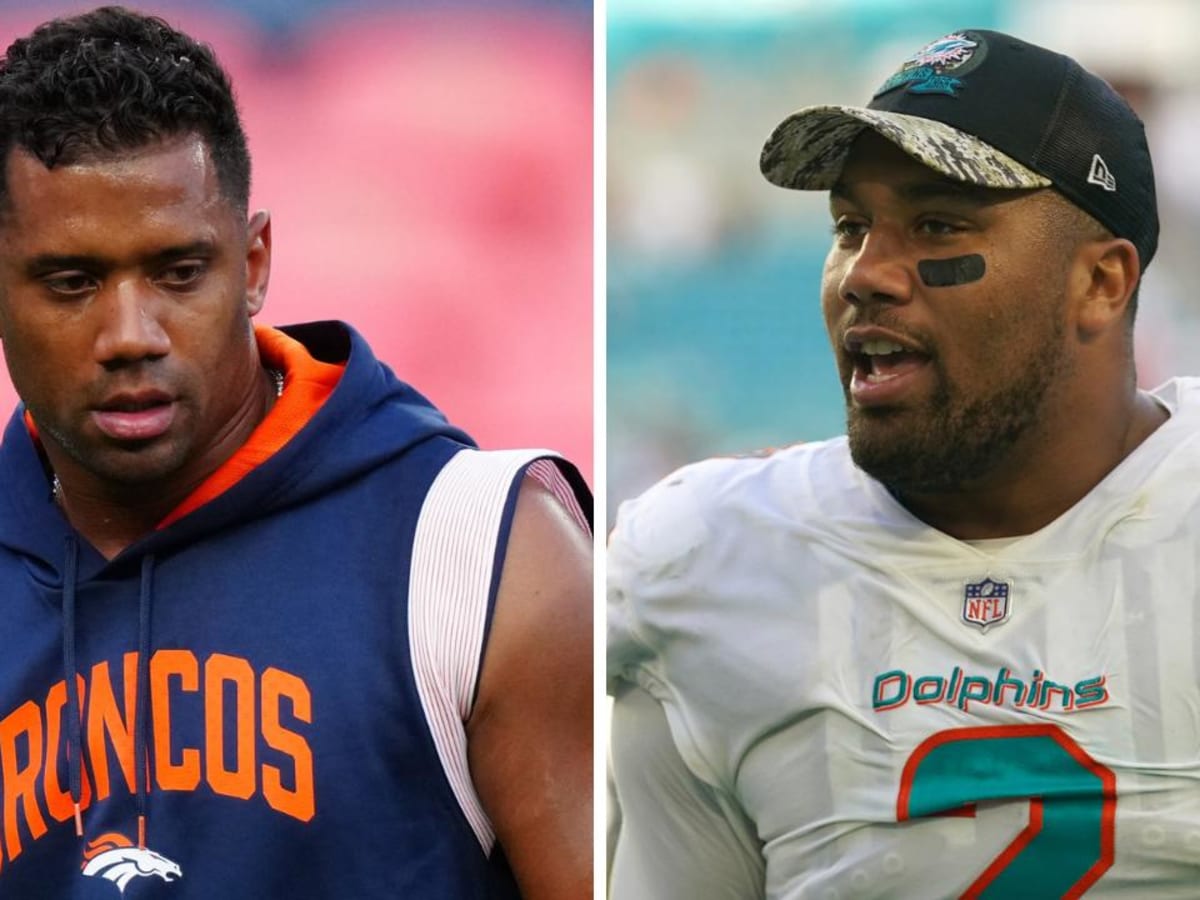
[0,6,250,211]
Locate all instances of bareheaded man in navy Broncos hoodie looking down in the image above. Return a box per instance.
[0,7,592,900]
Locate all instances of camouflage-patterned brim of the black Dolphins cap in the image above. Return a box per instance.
[758,106,1052,191]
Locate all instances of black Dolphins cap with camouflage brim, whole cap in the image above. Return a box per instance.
[760,30,1158,270]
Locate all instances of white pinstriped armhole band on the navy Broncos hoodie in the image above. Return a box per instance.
[408,450,574,853]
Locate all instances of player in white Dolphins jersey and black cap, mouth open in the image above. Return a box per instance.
[608,30,1200,900]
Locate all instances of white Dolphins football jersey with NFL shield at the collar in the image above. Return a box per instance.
[608,379,1200,900]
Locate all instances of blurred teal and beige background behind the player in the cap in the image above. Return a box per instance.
[607,0,1200,524]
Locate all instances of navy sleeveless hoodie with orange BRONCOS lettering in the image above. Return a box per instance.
[0,323,583,900]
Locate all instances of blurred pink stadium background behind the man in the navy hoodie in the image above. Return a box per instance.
[0,2,593,481]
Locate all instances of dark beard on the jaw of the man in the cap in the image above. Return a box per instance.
[847,317,1070,496]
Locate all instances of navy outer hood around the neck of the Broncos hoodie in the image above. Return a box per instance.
[0,322,474,584]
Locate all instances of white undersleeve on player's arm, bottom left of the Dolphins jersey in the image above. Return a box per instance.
[608,686,763,900]
